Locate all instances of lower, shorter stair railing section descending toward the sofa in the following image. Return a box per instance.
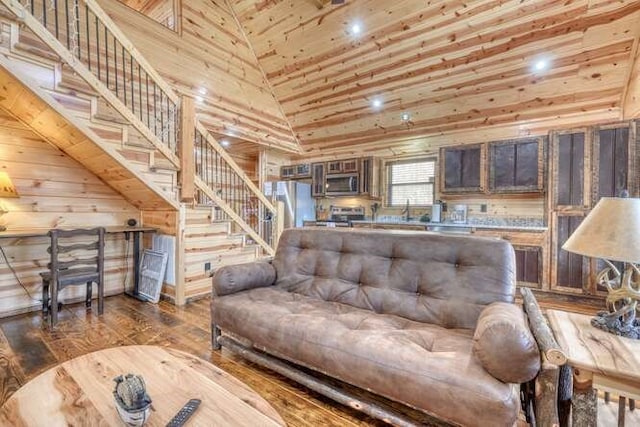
[193,126,277,255]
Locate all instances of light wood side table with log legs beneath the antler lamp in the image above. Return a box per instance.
[547,310,640,427]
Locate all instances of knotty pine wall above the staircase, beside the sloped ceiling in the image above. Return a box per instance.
[99,0,298,151]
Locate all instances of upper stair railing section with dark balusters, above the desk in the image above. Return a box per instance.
[6,0,180,167]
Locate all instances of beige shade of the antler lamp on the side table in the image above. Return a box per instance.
[562,197,640,263]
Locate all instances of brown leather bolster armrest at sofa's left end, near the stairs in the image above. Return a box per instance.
[213,262,276,297]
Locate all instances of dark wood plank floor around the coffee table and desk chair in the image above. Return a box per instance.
[0,295,385,427]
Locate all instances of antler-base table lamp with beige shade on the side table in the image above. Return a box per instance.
[562,197,640,339]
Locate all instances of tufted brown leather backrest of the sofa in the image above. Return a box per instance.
[273,228,515,329]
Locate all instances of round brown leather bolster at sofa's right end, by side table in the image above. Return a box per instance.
[473,302,540,383]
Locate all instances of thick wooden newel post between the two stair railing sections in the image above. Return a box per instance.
[179,96,196,203]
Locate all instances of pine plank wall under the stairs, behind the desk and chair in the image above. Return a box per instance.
[0,111,140,317]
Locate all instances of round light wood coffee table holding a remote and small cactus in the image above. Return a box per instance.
[0,346,285,427]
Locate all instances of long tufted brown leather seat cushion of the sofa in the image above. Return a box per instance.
[211,287,519,426]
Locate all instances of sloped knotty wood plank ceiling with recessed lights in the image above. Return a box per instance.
[228,0,640,155]
